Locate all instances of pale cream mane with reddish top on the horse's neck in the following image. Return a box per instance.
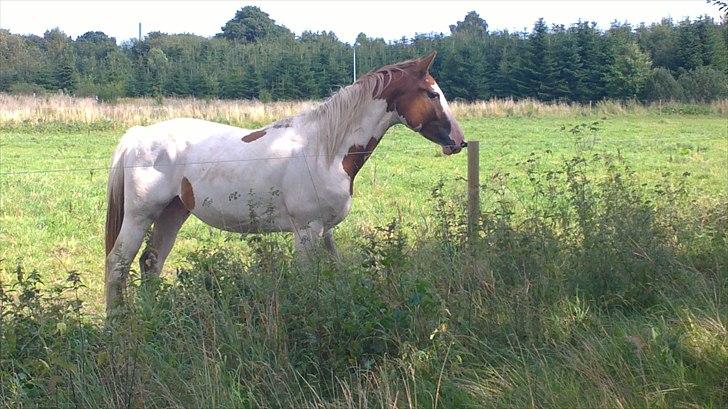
[302,60,416,161]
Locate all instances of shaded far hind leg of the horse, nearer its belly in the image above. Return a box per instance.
[139,196,190,277]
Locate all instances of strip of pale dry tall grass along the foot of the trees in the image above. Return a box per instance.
[0,94,728,126]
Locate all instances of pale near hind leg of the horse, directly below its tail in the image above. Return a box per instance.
[106,215,151,315]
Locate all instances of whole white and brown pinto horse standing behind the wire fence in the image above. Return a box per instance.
[105,52,465,313]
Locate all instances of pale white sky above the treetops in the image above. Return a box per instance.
[0,0,720,43]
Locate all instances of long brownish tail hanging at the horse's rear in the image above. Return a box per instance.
[105,145,126,256]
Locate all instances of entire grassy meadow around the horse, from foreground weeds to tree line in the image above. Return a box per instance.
[0,95,728,408]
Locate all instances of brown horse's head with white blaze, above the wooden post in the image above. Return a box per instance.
[381,51,466,155]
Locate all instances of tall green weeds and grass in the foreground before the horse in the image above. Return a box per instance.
[0,155,728,408]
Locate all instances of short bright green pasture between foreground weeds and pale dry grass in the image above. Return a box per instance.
[0,115,728,306]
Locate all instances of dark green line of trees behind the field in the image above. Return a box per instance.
[0,6,728,102]
